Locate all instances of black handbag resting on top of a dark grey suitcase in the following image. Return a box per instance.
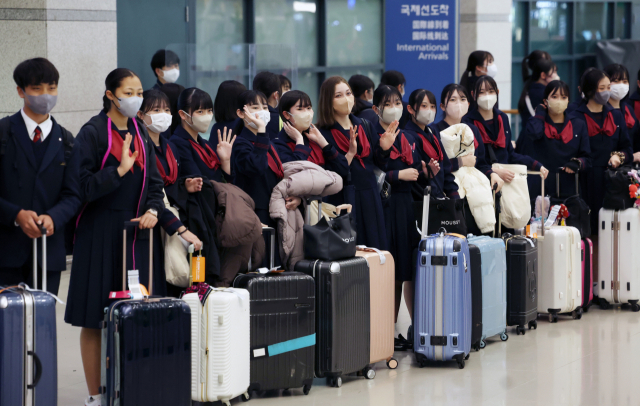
[303,208,356,261]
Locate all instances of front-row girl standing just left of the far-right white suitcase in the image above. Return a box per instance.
[570,69,633,233]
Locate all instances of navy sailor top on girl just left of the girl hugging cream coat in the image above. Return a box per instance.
[404,121,460,199]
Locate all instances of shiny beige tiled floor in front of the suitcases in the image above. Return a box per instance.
[57,272,640,406]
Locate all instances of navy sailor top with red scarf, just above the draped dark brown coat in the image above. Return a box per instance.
[170,126,233,183]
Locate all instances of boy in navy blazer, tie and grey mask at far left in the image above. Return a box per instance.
[0,58,81,294]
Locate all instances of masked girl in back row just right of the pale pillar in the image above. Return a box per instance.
[518,59,560,127]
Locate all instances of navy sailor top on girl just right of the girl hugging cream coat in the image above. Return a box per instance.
[462,107,542,171]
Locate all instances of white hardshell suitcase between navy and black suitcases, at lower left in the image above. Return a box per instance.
[182,288,250,405]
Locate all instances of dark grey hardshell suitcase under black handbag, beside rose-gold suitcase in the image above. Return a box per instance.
[295,257,375,387]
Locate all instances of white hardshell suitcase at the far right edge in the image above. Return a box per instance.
[598,208,640,312]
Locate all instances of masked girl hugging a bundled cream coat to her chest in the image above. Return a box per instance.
[423,83,504,190]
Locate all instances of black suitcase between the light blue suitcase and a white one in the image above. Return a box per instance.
[503,234,538,335]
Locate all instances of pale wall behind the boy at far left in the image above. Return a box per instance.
[0,0,117,135]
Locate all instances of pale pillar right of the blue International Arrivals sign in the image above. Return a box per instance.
[459,0,517,110]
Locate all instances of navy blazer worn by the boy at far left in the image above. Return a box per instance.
[0,112,80,271]
